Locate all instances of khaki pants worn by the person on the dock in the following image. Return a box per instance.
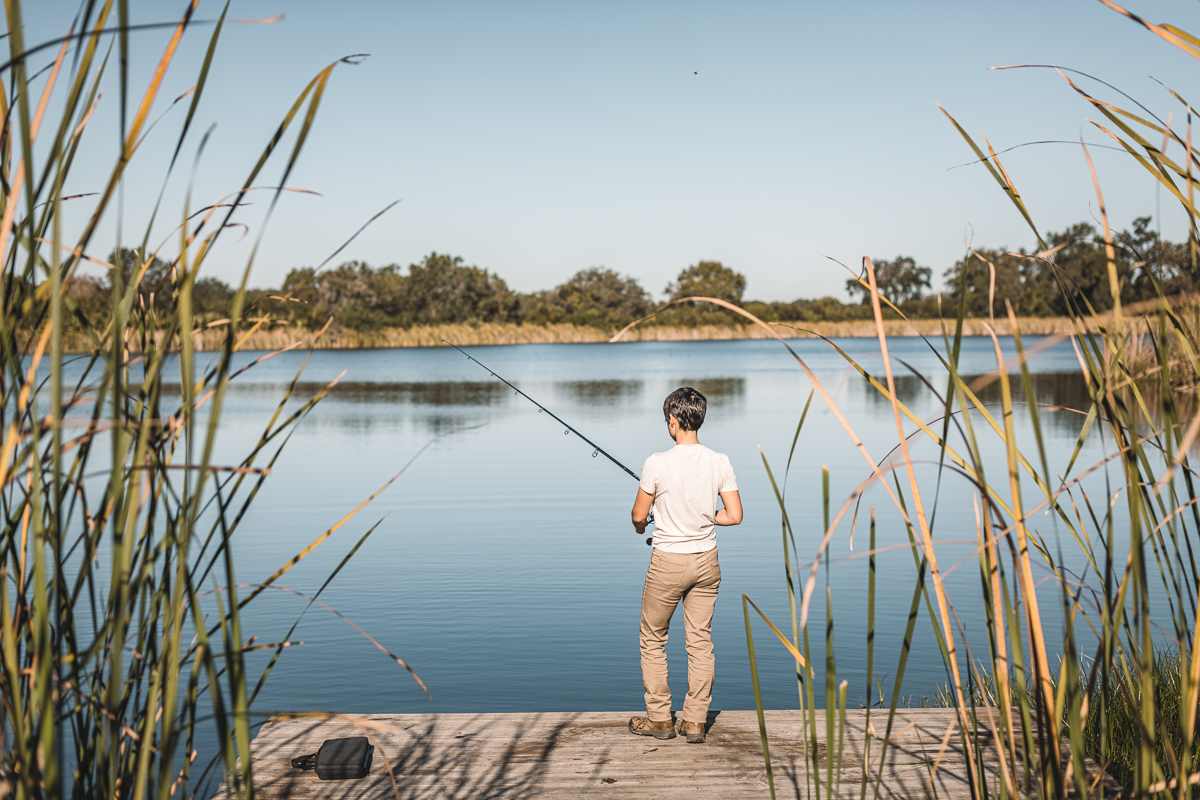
[641,547,721,723]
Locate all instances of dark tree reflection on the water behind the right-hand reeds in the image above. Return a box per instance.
[860,372,1092,433]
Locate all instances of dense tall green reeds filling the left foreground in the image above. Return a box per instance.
[0,0,415,800]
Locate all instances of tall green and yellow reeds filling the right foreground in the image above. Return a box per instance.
[614,0,1200,800]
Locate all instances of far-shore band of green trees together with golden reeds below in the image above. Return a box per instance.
[44,217,1200,353]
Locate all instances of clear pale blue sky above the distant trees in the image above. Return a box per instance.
[26,0,1200,299]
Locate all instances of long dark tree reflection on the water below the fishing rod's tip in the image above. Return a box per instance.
[156,380,511,405]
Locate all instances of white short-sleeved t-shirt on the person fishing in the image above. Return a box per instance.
[641,444,738,553]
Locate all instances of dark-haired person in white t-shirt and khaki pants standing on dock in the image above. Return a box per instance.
[629,386,742,744]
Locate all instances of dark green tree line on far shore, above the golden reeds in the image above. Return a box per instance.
[37,217,1200,330]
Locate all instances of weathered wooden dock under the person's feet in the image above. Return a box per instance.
[222,709,995,800]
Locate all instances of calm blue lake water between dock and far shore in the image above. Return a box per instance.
[177,338,1100,712]
